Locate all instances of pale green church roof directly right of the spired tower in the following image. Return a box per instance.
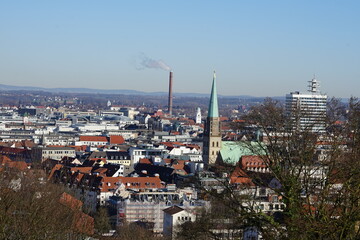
[220,141,265,166]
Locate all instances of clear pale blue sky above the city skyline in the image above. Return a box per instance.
[0,0,360,97]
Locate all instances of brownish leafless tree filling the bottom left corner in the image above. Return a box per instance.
[0,168,90,239]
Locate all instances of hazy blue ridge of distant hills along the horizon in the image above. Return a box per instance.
[0,84,284,100]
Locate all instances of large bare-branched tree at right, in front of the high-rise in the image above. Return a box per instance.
[180,98,360,239]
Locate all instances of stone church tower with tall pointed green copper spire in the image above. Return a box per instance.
[203,72,221,165]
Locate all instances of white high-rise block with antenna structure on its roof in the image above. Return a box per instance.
[285,77,327,132]
